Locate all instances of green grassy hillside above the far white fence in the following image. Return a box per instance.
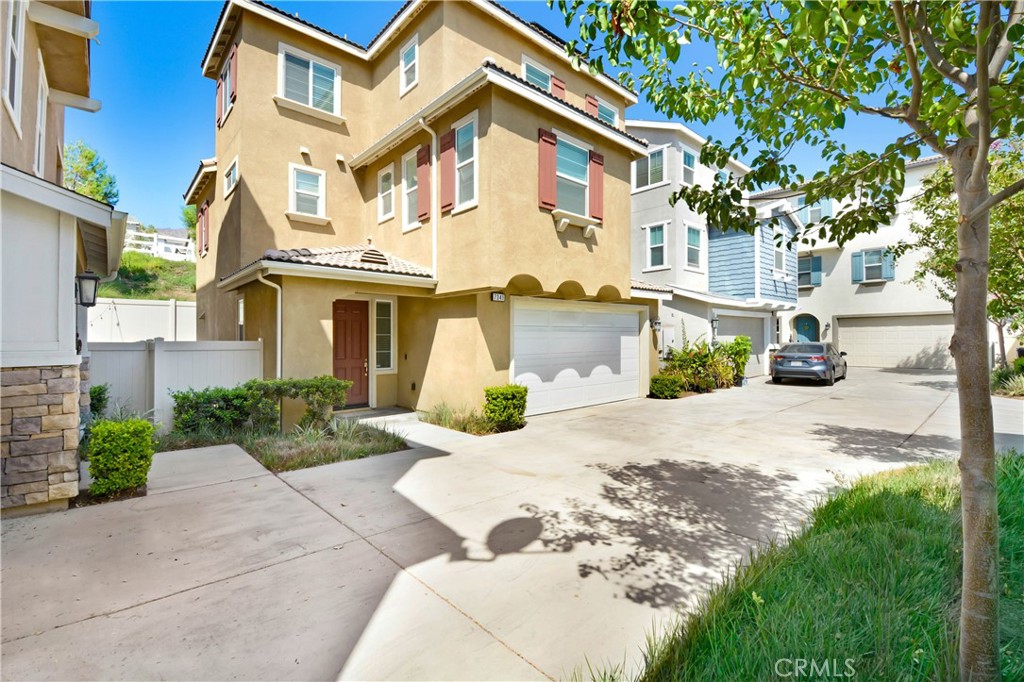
[98,251,196,301]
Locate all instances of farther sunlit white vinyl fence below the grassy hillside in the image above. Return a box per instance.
[88,298,196,343]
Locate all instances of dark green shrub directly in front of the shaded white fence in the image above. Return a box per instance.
[171,382,279,434]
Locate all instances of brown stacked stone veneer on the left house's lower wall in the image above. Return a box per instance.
[0,365,82,510]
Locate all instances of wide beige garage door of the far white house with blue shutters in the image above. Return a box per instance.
[838,314,953,370]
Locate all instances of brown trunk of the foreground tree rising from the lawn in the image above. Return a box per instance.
[949,138,999,682]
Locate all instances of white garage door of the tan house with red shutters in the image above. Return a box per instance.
[512,298,641,415]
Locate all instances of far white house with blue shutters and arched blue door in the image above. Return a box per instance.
[751,157,966,370]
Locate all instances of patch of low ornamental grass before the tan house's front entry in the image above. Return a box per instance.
[157,419,408,473]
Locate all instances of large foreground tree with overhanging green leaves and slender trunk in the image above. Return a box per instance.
[561,0,1024,682]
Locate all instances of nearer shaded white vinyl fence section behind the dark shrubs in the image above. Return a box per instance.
[89,339,263,433]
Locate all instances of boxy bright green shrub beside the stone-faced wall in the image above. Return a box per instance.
[89,419,155,495]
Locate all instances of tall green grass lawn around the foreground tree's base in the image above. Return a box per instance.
[641,453,1024,680]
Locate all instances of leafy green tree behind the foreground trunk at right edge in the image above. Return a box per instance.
[895,138,1024,365]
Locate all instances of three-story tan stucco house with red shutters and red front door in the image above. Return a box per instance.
[185,0,656,414]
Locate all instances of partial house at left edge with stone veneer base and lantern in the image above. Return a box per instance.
[0,0,126,515]
